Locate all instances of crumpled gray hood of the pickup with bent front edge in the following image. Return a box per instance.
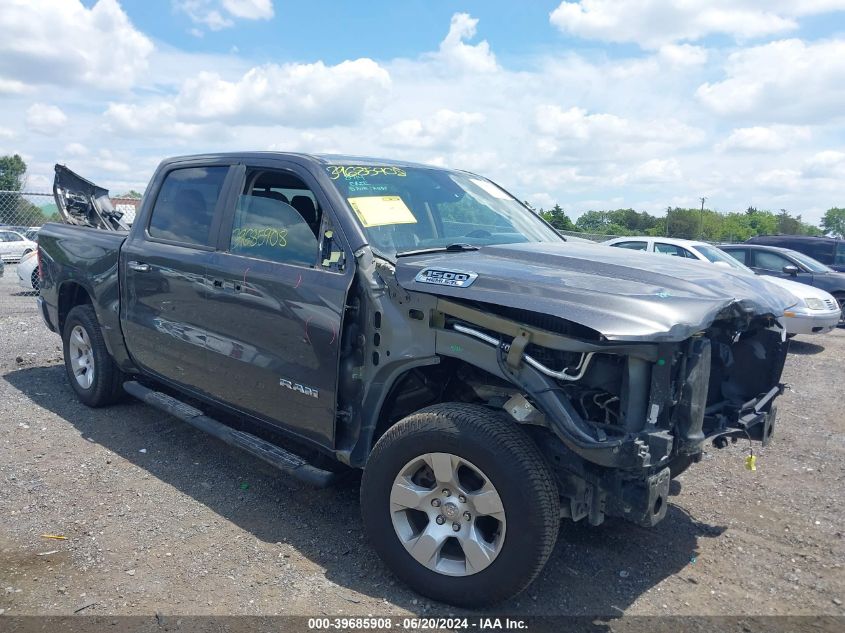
[396,242,795,341]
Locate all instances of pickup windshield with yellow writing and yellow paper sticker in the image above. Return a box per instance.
[326,164,563,259]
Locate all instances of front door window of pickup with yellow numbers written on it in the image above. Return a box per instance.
[229,171,322,267]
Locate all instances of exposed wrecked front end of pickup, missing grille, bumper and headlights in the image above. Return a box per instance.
[443,298,786,526]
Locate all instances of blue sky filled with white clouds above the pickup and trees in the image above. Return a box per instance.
[0,0,845,221]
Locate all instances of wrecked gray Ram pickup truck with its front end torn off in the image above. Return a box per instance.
[39,153,792,606]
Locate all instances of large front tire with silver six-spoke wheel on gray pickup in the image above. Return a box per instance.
[361,403,560,607]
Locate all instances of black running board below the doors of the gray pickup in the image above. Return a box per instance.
[123,380,338,488]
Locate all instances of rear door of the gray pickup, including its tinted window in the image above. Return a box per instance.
[120,163,236,391]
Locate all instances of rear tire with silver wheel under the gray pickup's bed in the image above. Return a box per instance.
[62,304,123,407]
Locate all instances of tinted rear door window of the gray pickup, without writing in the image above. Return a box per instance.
[148,166,229,246]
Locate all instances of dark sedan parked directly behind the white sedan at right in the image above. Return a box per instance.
[719,243,845,325]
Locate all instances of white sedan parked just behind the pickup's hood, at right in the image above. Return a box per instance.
[602,236,842,336]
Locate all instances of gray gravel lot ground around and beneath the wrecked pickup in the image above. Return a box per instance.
[0,265,845,616]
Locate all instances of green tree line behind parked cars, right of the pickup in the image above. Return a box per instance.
[537,204,845,242]
